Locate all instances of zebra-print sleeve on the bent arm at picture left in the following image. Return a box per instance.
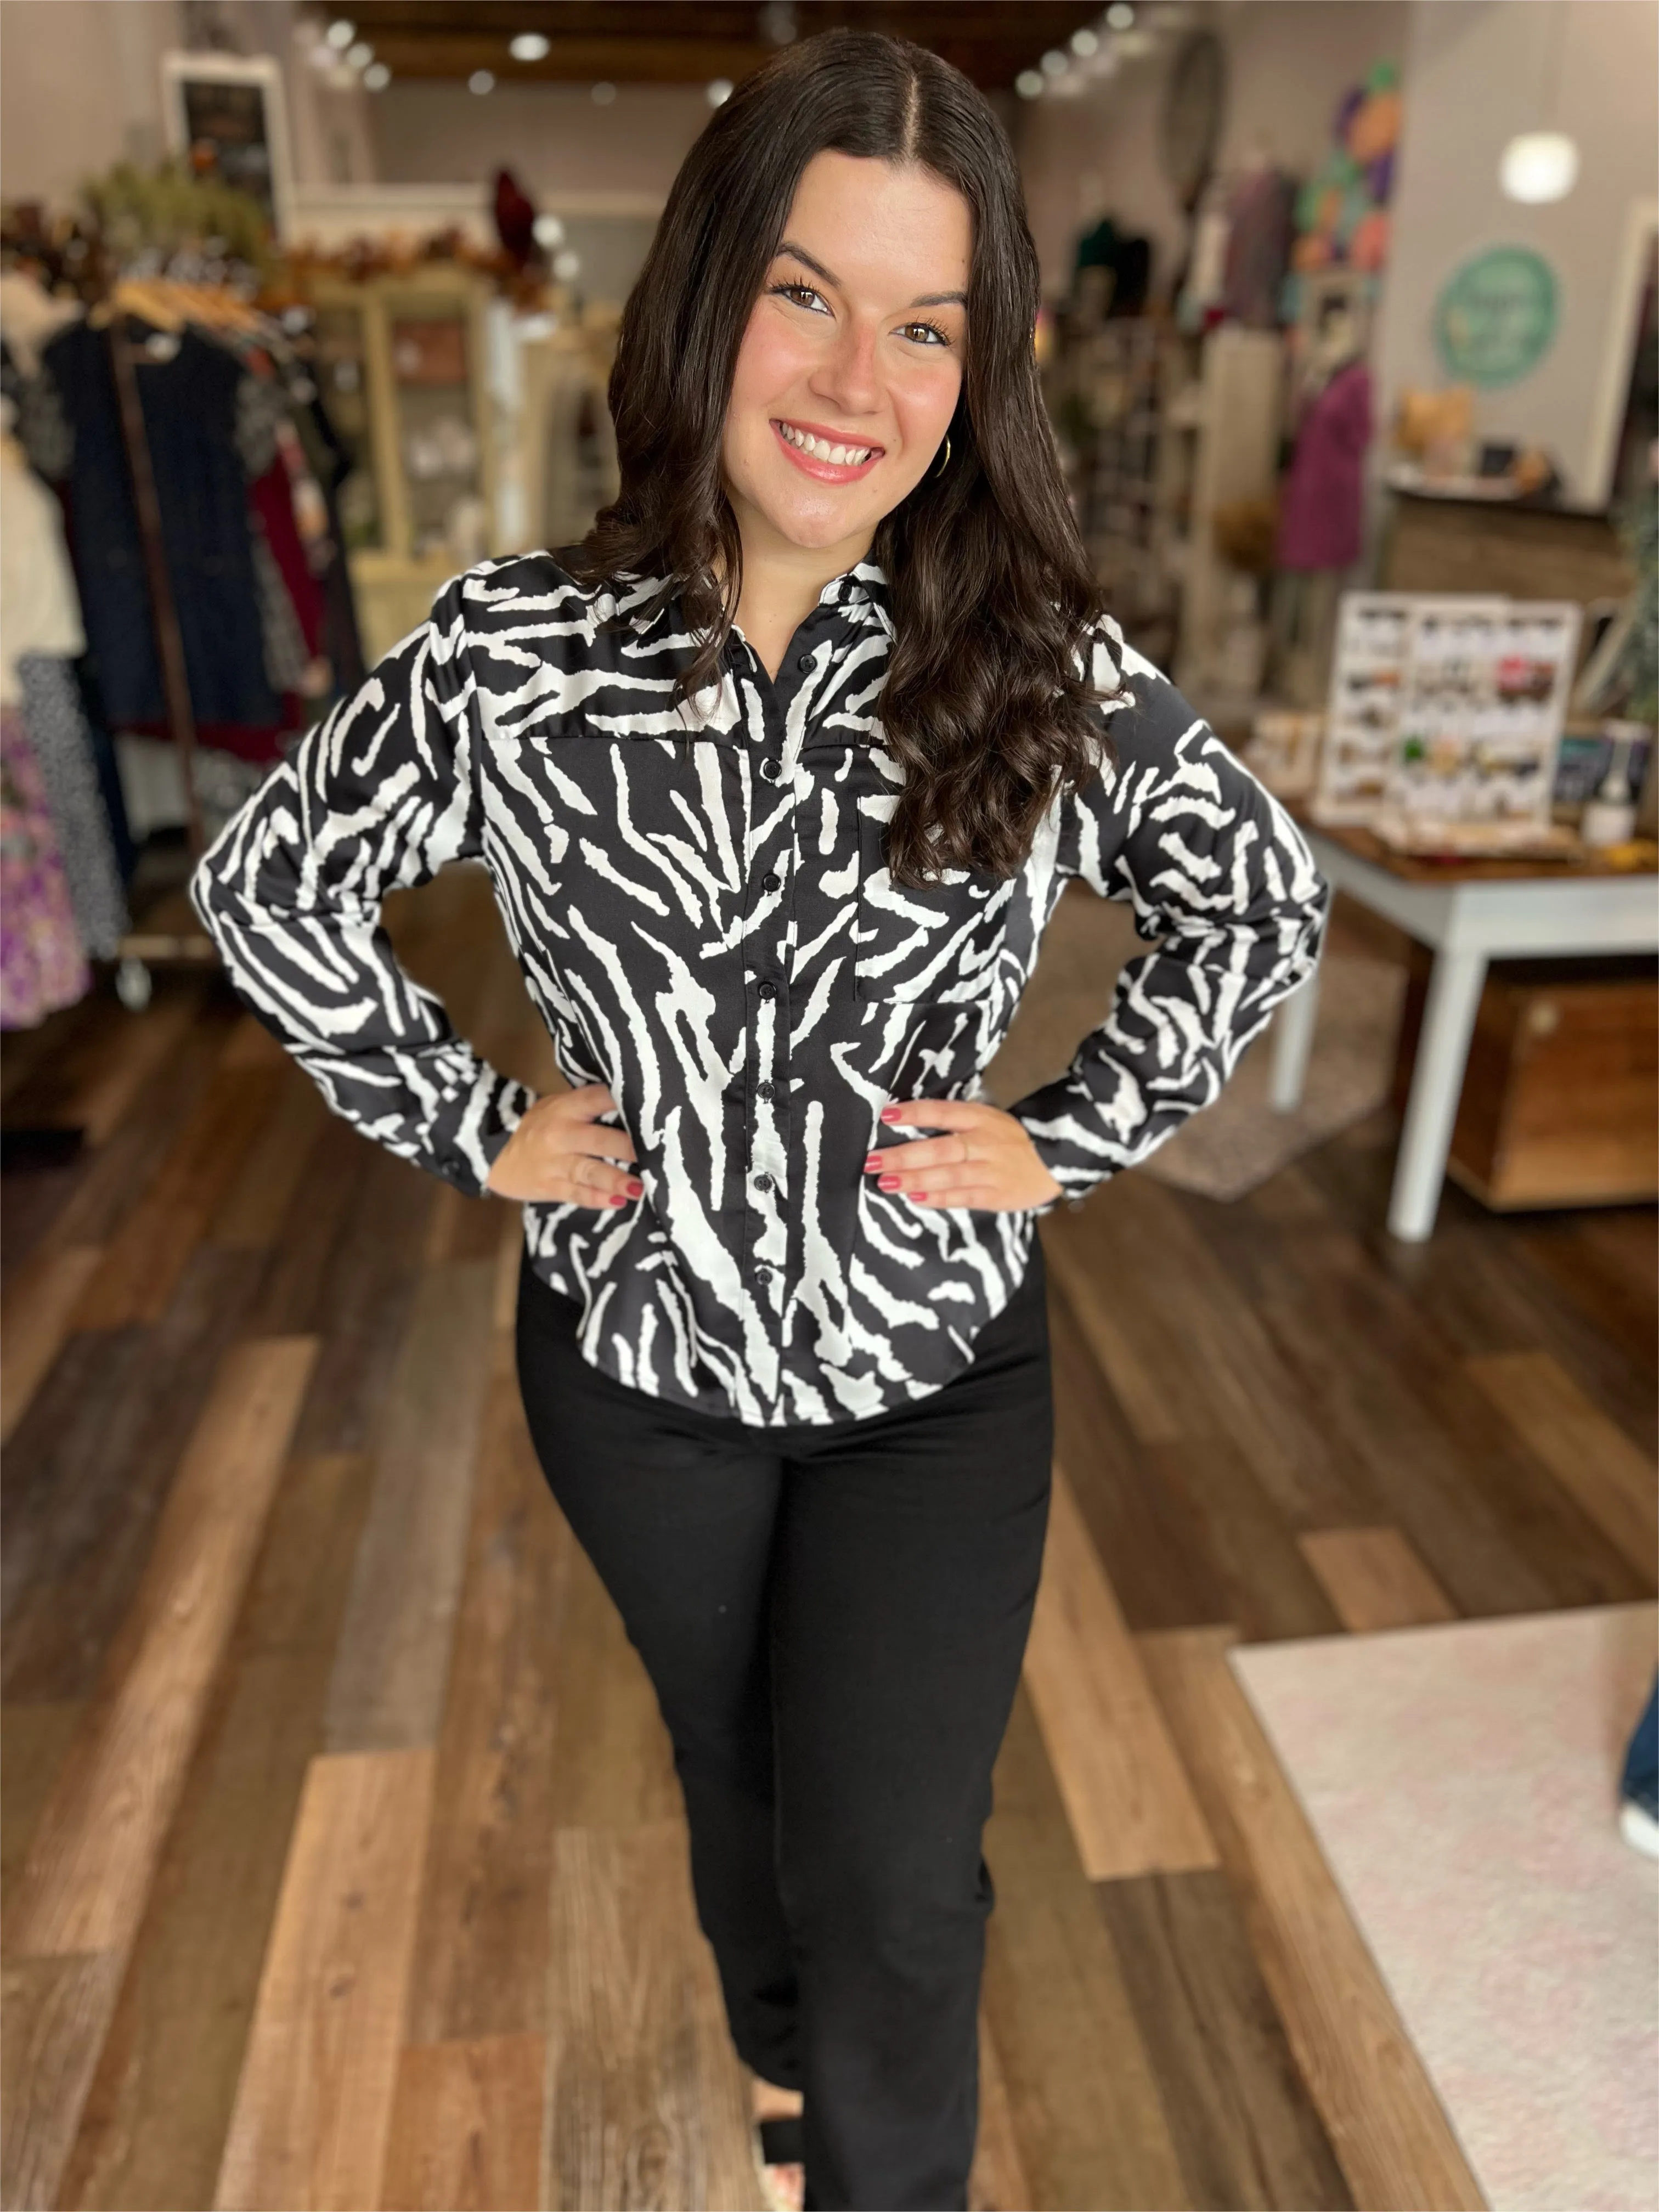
[190,579,533,1194]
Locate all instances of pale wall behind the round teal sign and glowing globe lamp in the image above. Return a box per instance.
[1374,0,1659,500]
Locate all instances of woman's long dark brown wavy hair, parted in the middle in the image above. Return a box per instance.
[566,31,1119,885]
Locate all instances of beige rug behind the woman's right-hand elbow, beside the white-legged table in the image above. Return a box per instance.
[986,885,1404,1201]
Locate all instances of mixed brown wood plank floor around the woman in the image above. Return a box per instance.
[0,870,1659,2212]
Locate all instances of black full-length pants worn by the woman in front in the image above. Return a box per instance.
[517,1248,1053,2212]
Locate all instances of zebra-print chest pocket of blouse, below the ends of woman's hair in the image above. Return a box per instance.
[851,810,1013,1007]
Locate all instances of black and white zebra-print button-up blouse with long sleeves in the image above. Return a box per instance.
[190,553,1327,1427]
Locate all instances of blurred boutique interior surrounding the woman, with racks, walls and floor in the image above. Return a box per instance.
[0,0,1659,2212]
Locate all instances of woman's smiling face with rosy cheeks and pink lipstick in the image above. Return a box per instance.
[721,153,973,566]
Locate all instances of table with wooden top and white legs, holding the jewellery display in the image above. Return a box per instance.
[1269,816,1659,1243]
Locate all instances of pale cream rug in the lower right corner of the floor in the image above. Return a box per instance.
[1232,1606,1659,2212]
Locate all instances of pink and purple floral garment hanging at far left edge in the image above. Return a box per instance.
[0,708,93,1029]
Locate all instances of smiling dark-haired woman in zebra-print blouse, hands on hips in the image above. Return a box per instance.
[195,33,1325,2208]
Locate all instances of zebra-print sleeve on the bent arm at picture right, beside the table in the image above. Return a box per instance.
[1011,644,1329,1212]
